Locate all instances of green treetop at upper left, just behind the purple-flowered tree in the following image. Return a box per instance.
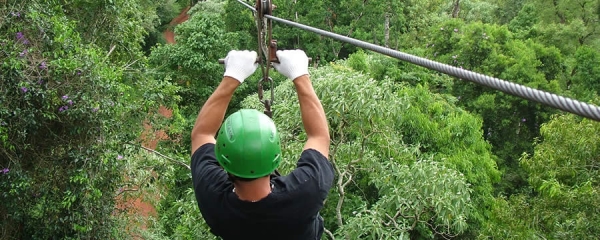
[59,0,161,62]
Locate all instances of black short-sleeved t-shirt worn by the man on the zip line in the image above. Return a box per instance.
[191,143,334,240]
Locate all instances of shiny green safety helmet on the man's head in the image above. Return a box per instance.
[215,109,281,178]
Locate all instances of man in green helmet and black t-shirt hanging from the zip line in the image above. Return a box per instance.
[191,50,334,240]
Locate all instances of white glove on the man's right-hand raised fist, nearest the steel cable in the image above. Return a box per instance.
[273,50,308,81]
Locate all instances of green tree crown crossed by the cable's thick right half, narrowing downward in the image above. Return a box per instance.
[429,20,564,194]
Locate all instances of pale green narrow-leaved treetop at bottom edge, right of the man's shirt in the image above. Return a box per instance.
[338,161,472,239]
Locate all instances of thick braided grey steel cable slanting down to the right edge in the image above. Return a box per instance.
[265,15,600,121]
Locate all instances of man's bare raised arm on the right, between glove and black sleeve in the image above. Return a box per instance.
[294,75,330,159]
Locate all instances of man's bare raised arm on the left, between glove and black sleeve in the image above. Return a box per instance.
[191,77,240,154]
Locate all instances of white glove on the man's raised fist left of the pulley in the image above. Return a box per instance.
[223,50,258,83]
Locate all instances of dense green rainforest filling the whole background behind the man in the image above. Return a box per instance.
[0,0,600,239]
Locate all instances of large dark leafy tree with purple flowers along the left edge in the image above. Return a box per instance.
[0,1,175,239]
